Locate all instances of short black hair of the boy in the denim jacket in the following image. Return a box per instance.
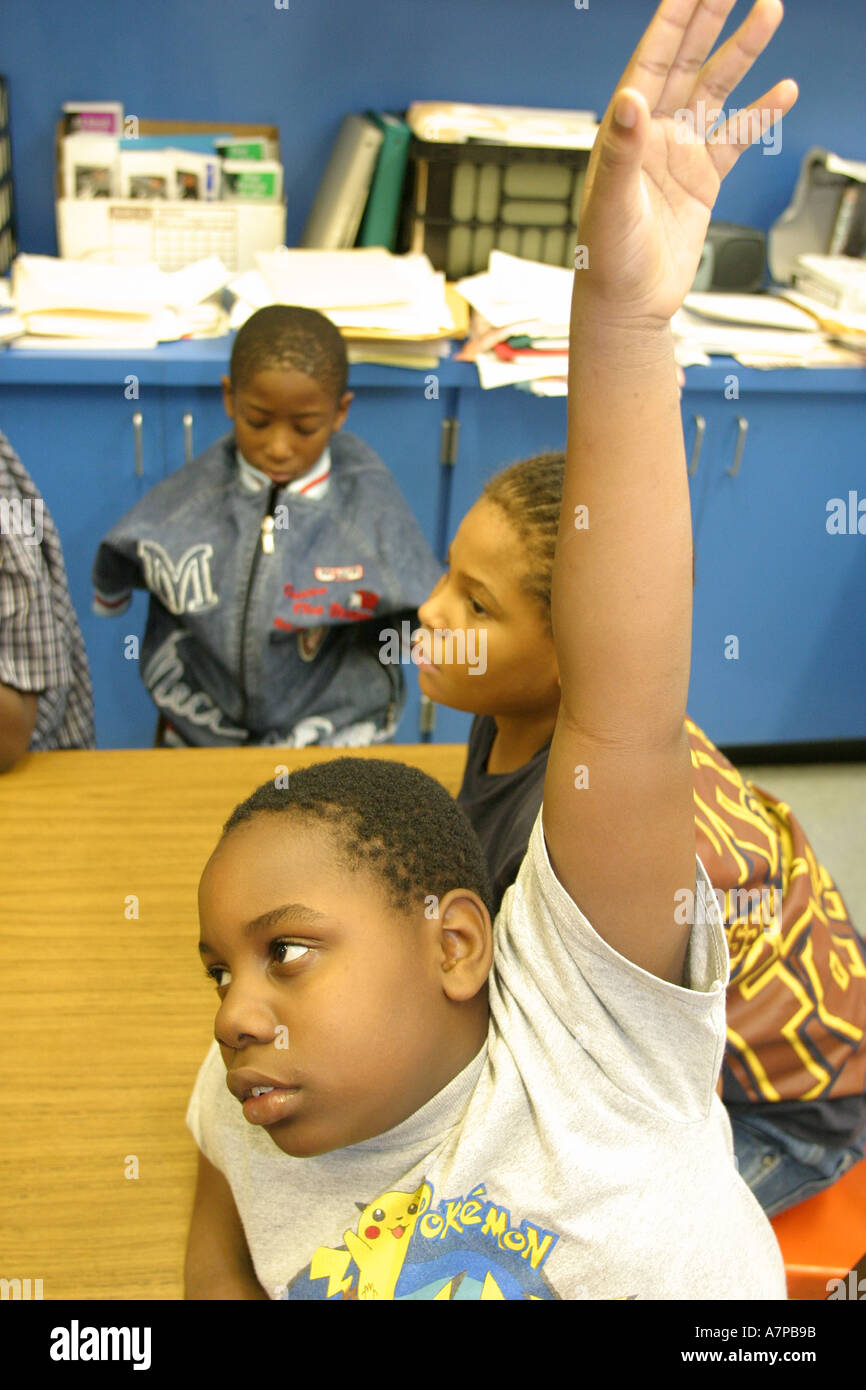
[228,304,349,402]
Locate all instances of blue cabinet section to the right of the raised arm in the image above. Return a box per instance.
[684,371,866,744]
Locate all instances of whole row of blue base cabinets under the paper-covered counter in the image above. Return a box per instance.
[0,347,866,748]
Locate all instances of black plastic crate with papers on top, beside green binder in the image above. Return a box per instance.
[399,138,589,281]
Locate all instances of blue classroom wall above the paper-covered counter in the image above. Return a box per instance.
[0,0,866,254]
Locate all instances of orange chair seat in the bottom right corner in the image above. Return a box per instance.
[771,1159,866,1300]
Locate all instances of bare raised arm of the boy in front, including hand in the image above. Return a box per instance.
[544,0,796,984]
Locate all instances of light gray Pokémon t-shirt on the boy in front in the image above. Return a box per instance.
[186,813,785,1300]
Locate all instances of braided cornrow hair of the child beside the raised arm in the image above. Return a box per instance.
[481,452,566,631]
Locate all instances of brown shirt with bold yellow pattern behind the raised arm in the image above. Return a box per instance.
[687,720,866,1111]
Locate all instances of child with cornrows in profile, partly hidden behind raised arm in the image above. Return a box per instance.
[418,453,866,1215]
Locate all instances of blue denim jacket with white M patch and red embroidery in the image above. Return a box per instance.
[93,431,441,748]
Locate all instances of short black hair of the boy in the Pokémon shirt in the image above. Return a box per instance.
[222,758,493,916]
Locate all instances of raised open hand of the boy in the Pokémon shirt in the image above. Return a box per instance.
[575,0,798,324]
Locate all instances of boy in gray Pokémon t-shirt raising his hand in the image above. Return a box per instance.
[186,0,795,1301]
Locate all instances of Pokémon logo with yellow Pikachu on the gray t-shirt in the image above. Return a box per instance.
[281,1182,559,1302]
